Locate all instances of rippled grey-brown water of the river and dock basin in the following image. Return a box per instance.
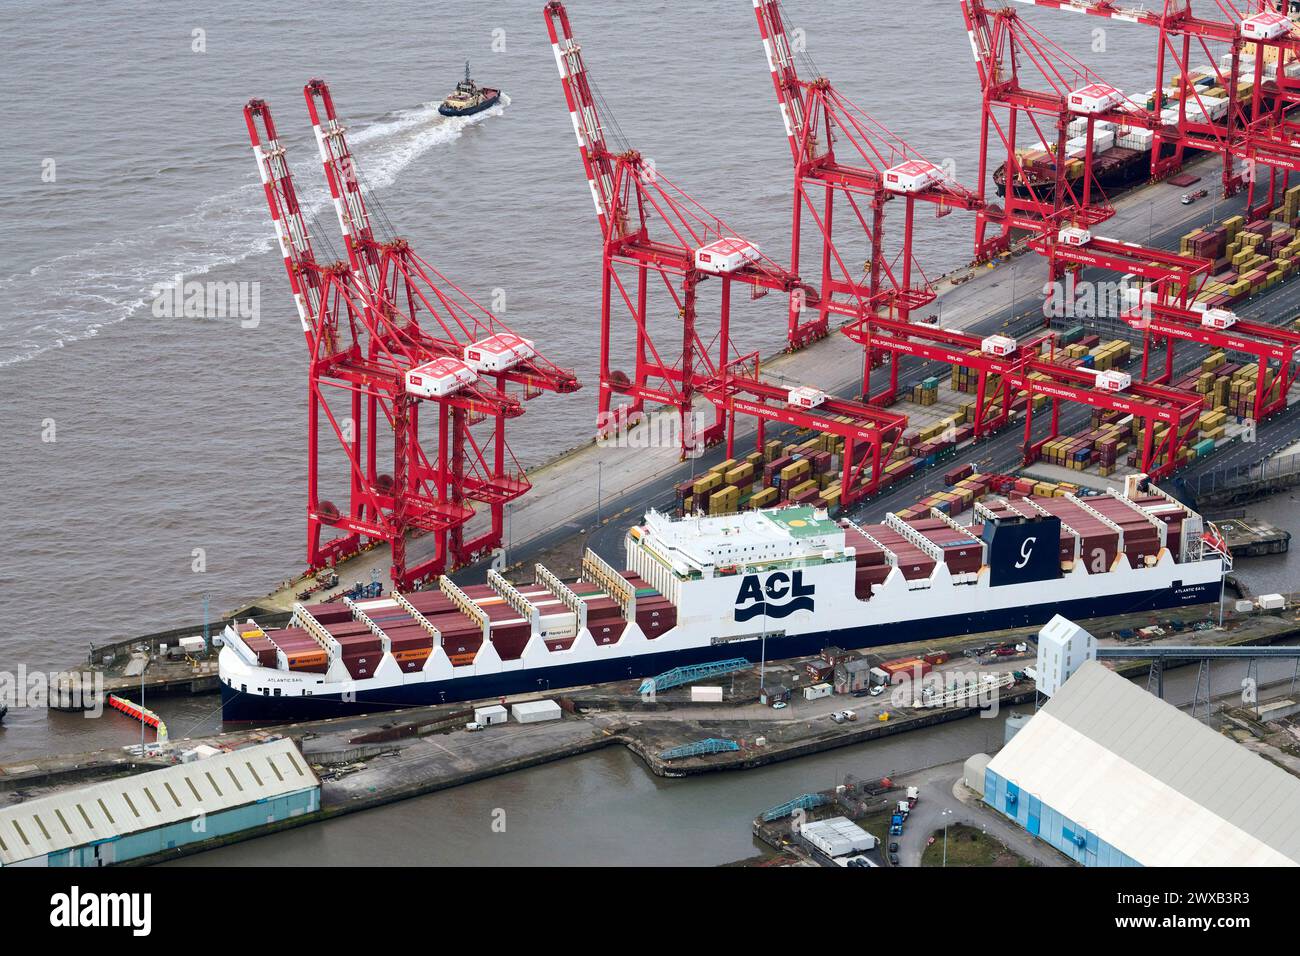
[0,0,1289,862]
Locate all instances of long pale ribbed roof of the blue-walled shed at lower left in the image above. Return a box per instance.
[0,740,319,865]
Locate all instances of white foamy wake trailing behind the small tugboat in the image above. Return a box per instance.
[0,94,510,368]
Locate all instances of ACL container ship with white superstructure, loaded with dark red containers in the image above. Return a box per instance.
[220,481,1225,722]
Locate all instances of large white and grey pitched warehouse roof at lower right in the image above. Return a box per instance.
[988,661,1300,866]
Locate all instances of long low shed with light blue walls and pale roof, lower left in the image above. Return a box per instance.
[0,740,320,866]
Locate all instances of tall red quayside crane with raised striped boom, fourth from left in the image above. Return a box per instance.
[754,0,984,347]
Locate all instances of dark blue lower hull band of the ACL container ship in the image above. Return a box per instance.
[221,581,1221,723]
